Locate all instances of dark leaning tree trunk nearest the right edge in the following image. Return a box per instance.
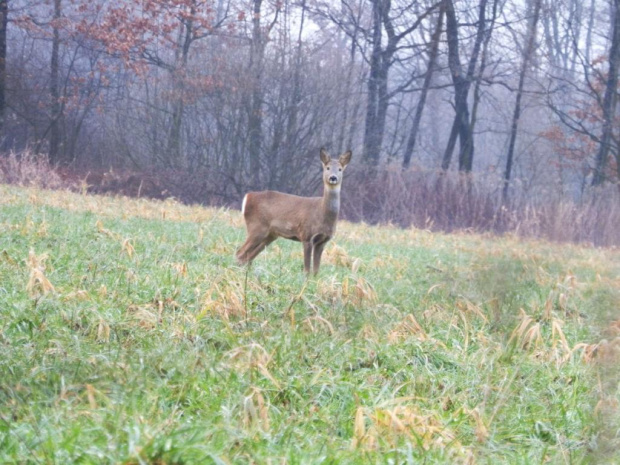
[592,0,620,186]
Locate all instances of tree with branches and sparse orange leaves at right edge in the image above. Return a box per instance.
[542,0,620,189]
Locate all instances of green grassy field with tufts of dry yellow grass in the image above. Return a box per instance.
[0,186,620,464]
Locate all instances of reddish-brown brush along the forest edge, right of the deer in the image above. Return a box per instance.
[342,169,620,246]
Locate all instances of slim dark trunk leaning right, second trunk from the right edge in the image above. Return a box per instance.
[502,0,541,199]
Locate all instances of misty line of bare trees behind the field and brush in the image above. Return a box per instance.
[0,0,620,201]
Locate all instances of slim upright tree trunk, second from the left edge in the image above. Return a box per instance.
[49,0,64,165]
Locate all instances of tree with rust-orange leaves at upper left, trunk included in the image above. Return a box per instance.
[80,0,229,168]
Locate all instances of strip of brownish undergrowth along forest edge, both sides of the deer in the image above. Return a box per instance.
[0,152,620,246]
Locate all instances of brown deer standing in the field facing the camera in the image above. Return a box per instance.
[235,148,352,275]
